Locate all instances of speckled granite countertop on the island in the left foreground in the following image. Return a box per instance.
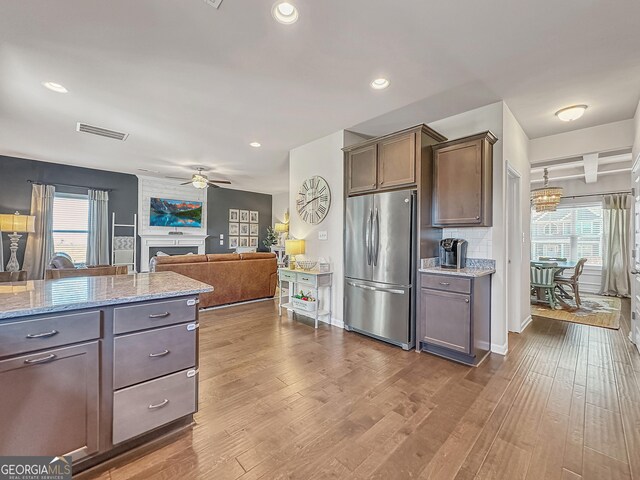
[0,272,213,320]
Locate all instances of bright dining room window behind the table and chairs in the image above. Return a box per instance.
[531,203,602,267]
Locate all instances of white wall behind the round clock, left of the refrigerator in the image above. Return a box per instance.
[289,130,344,326]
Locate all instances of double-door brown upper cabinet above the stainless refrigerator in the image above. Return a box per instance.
[344,125,446,196]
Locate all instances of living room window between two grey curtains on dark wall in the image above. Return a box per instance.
[53,193,89,264]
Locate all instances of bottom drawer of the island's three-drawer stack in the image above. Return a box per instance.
[113,370,198,445]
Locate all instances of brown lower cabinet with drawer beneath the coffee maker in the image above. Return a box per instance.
[416,273,491,365]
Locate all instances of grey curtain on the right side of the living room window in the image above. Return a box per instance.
[87,190,109,265]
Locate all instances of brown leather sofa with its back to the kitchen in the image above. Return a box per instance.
[152,252,278,308]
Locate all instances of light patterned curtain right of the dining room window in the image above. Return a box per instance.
[600,194,632,297]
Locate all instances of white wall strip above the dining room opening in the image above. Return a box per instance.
[529,120,634,164]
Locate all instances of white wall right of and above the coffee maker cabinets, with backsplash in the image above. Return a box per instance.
[429,102,512,354]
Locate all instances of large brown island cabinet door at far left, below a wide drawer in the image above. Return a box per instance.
[0,341,100,461]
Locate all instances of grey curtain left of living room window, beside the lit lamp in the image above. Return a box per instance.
[22,185,56,280]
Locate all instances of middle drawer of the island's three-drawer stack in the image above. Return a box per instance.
[113,323,198,390]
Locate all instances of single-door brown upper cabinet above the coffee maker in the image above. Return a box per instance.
[433,132,497,227]
